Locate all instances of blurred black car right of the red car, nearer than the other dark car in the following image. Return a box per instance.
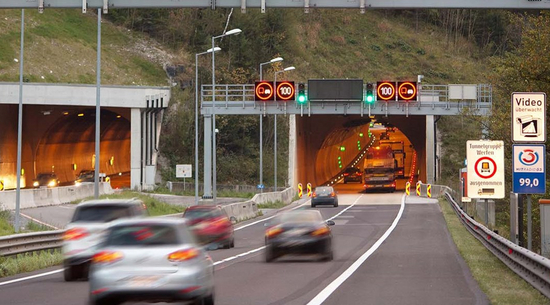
[265,210,334,263]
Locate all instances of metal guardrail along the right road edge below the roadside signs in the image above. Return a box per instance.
[445,187,550,298]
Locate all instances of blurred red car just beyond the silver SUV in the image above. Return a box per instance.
[183,205,235,249]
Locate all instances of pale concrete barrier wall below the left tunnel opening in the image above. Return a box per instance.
[0,182,114,210]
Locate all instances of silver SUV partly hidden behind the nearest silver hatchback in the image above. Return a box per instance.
[62,198,148,281]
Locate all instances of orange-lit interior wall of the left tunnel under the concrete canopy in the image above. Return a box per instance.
[0,105,130,189]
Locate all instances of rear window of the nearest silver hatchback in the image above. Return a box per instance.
[105,224,179,247]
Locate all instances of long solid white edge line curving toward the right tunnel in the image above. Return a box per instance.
[307,195,405,305]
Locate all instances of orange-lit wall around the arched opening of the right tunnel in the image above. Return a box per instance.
[296,115,432,186]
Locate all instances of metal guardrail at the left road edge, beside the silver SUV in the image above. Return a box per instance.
[0,230,65,256]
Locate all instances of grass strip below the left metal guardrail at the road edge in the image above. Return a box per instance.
[0,250,63,277]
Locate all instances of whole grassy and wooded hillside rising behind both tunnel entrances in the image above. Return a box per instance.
[0,9,489,185]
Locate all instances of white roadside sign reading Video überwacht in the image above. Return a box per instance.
[511,92,546,143]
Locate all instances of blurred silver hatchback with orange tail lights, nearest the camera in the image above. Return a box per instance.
[89,218,214,305]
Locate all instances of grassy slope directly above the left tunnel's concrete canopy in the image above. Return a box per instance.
[0,9,173,86]
